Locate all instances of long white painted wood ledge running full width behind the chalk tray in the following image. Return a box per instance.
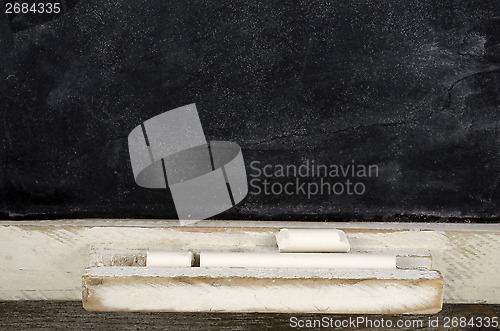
[0,220,500,312]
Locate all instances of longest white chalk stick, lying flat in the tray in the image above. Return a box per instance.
[200,252,396,269]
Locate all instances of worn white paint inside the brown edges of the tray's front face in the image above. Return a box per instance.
[89,283,439,313]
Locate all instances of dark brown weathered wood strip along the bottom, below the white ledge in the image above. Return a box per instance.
[0,301,500,331]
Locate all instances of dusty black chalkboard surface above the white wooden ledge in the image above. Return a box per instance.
[0,0,500,222]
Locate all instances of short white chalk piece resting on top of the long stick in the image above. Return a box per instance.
[276,229,350,253]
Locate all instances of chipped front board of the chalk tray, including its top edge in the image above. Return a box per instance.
[84,267,442,313]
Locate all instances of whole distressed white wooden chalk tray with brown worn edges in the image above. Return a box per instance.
[82,227,444,314]
